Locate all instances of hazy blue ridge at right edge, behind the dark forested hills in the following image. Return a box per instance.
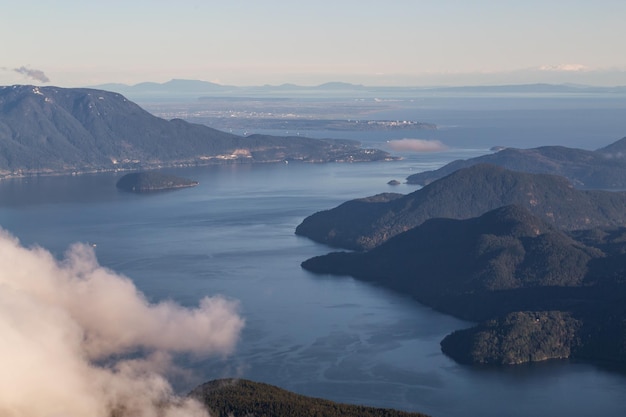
[407,138,626,189]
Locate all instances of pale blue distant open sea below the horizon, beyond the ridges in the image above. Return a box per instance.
[168,93,626,150]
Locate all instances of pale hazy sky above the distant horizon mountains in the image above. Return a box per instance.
[0,0,626,87]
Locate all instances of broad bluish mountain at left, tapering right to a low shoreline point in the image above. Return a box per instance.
[0,85,392,177]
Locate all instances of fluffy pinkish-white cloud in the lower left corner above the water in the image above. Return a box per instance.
[0,230,243,417]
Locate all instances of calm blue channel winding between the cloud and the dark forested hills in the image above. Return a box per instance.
[0,154,626,417]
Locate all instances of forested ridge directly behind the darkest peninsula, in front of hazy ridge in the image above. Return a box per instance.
[296,164,626,250]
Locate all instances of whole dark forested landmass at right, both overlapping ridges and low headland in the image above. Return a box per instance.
[297,164,626,365]
